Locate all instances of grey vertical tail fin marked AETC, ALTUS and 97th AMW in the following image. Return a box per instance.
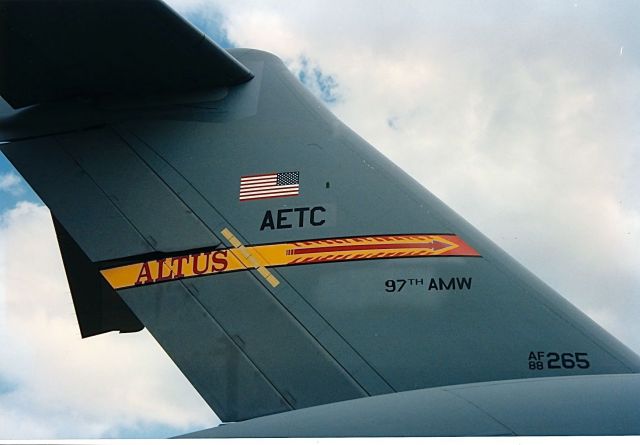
[0,0,640,421]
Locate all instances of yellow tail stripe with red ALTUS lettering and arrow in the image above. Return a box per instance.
[100,228,480,289]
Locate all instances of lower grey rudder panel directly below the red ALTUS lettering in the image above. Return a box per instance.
[120,282,291,419]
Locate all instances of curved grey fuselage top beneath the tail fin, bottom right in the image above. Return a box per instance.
[182,374,640,438]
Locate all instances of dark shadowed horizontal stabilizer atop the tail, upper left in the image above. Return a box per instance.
[0,0,252,108]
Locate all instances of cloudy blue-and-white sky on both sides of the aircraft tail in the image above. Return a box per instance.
[0,0,640,439]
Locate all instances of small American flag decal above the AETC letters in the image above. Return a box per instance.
[240,172,300,201]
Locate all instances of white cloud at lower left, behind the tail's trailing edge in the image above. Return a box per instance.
[0,202,218,439]
